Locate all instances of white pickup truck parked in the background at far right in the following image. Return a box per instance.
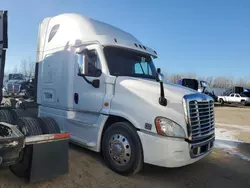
[218,93,250,106]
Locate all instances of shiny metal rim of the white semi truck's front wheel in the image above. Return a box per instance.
[108,134,131,165]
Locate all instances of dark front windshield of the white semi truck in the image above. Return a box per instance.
[104,47,156,79]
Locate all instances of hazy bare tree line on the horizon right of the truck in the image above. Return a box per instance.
[165,73,250,88]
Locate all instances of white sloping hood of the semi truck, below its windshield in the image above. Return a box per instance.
[109,76,198,132]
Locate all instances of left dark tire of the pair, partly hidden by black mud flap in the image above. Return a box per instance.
[9,117,42,178]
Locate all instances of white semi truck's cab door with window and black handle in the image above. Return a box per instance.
[73,45,105,113]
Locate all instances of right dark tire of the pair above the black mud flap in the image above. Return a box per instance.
[39,117,61,134]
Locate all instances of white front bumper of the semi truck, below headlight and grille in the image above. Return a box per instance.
[138,131,214,168]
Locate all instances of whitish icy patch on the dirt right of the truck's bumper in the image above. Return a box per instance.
[214,125,250,162]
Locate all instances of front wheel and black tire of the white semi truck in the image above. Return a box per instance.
[102,122,143,175]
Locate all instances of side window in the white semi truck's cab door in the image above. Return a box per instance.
[77,50,102,77]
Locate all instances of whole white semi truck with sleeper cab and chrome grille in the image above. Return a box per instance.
[36,14,215,175]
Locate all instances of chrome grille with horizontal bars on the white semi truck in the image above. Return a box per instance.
[188,100,214,139]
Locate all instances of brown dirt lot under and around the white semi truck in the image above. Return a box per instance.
[0,107,250,188]
